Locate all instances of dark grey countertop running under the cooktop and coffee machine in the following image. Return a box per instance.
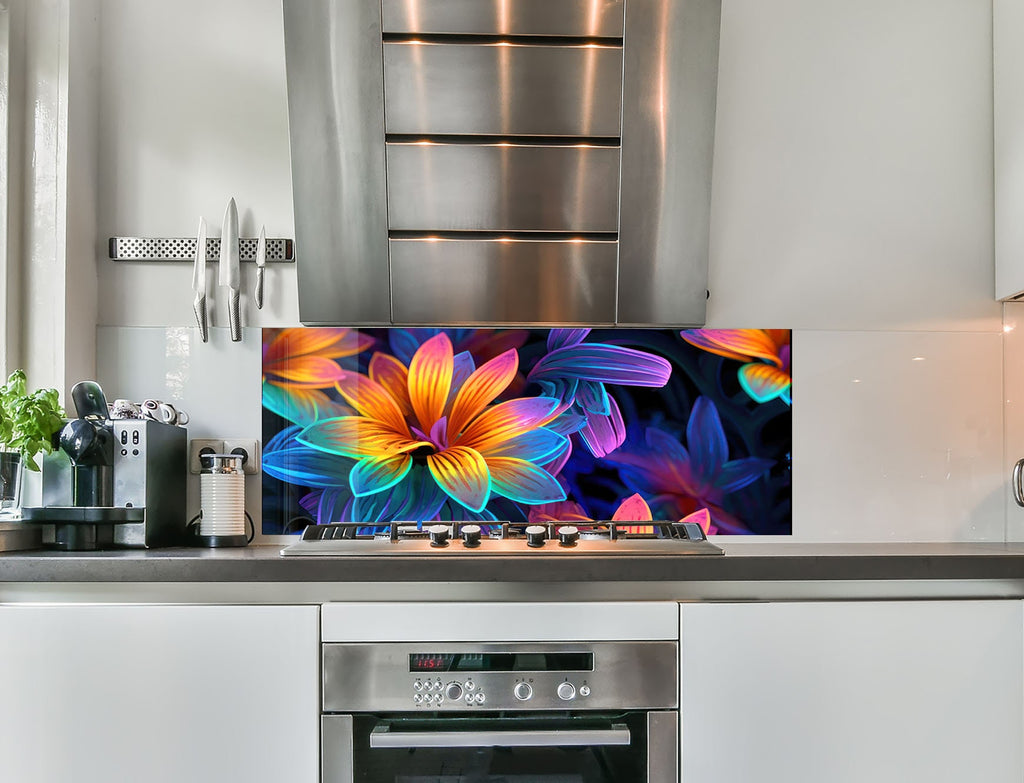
[0,539,1024,583]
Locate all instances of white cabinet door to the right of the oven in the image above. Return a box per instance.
[680,601,1024,783]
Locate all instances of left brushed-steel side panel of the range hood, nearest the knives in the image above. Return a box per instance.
[284,0,391,325]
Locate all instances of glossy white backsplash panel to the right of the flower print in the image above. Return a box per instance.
[793,332,1006,541]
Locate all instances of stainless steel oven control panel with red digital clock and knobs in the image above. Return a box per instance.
[323,642,679,712]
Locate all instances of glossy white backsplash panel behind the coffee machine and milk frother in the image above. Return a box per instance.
[96,327,262,530]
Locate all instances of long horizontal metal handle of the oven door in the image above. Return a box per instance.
[370,724,632,748]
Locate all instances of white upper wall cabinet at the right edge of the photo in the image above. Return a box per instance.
[992,0,1024,299]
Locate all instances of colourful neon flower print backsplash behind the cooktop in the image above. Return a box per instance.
[263,328,793,535]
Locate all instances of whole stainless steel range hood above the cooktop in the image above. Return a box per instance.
[284,0,721,325]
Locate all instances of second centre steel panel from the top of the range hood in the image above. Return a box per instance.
[384,42,623,137]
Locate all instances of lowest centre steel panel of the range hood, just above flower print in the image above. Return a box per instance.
[391,240,617,323]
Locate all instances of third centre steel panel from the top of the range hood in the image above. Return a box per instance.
[387,143,618,232]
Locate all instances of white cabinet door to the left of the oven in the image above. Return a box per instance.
[0,605,319,783]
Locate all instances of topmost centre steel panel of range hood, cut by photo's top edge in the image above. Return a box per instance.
[382,0,623,38]
